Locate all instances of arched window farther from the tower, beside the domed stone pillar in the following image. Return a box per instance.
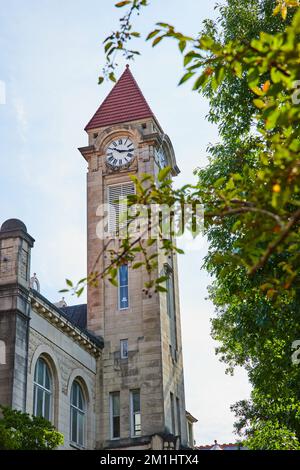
[33,357,52,421]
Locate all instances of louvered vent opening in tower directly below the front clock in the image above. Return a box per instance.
[108,182,135,234]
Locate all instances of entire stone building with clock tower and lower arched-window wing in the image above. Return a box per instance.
[0,67,196,449]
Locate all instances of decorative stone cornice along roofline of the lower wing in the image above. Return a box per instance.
[30,294,102,357]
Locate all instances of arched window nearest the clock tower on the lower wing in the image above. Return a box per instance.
[70,380,86,446]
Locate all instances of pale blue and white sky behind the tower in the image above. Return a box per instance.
[0,0,250,444]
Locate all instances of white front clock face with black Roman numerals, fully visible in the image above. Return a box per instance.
[106,137,134,168]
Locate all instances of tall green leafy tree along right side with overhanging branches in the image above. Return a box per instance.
[63,0,300,448]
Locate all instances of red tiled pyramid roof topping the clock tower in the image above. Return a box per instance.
[85,65,155,131]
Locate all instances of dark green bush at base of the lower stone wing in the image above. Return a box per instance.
[0,406,64,450]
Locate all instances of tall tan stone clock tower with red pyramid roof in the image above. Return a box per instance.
[79,66,187,449]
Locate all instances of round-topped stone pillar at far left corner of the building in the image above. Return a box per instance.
[0,219,34,411]
